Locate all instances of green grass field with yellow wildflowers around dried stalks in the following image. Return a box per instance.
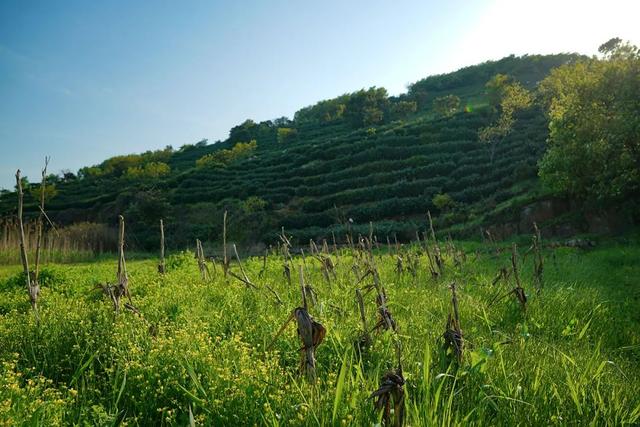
[0,239,640,426]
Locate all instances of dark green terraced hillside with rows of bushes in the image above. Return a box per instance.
[0,54,577,249]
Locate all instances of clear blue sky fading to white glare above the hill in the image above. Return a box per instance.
[0,0,640,188]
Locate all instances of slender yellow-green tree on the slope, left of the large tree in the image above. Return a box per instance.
[478,74,533,163]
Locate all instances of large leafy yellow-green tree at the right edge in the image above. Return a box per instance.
[539,39,640,202]
